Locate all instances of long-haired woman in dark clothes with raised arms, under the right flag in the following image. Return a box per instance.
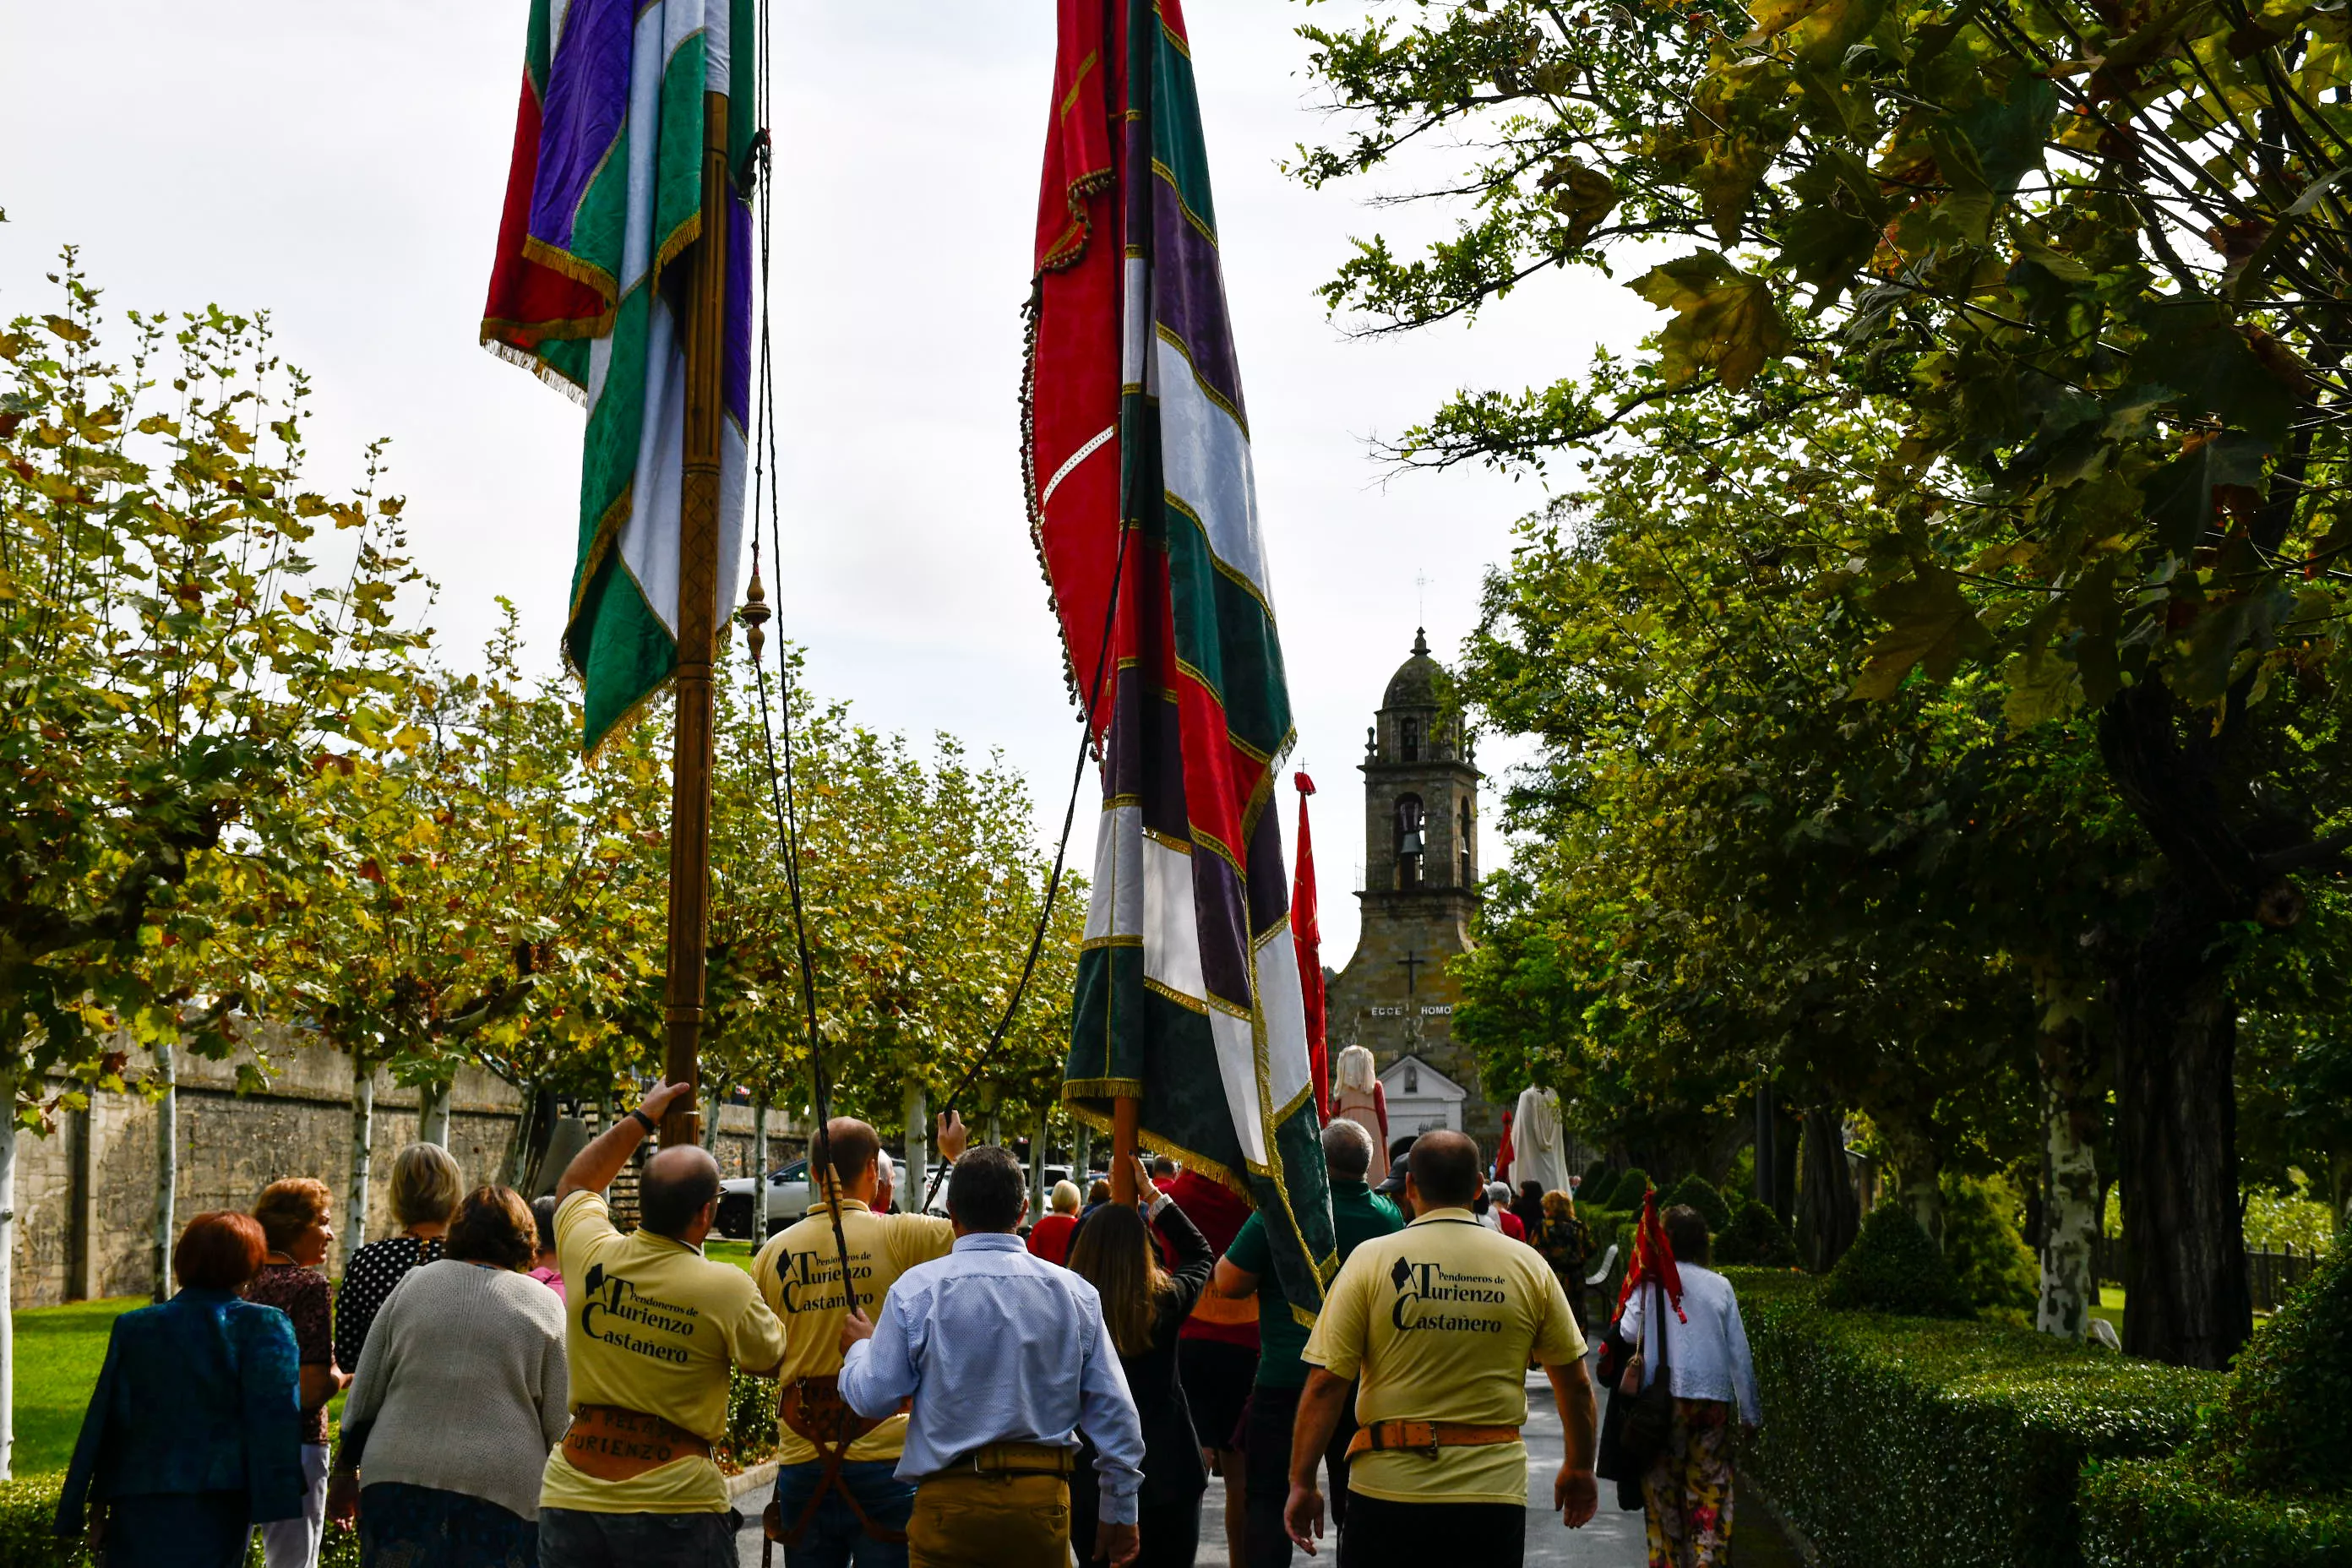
[1070,1159,1223,1568]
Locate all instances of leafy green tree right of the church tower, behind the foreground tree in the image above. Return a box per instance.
[1458,393,2116,1333]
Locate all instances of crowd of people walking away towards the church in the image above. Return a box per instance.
[57,1081,1761,1568]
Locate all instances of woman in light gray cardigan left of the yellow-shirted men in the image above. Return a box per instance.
[327,1187,569,1568]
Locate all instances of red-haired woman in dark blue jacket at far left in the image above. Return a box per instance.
[57,1213,303,1568]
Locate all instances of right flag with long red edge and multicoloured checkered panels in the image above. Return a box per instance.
[1023,0,1338,1314]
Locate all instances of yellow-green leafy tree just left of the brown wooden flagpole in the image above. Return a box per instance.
[264,607,668,1249]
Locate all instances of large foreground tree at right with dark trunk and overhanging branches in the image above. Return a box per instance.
[1296,0,2352,1366]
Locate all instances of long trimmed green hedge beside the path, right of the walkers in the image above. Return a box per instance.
[1729,1270,2223,1568]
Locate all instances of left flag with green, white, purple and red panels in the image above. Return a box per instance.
[468,0,757,752]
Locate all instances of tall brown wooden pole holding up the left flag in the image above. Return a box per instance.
[661,92,729,1147]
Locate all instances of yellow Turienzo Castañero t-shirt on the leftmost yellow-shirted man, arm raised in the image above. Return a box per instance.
[539,1192,783,1514]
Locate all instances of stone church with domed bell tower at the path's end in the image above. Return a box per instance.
[1326,633,1503,1159]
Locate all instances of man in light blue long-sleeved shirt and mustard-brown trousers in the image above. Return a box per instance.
[840,1147,1143,1568]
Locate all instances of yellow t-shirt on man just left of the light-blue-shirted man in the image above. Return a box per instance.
[750,1199,955,1465]
